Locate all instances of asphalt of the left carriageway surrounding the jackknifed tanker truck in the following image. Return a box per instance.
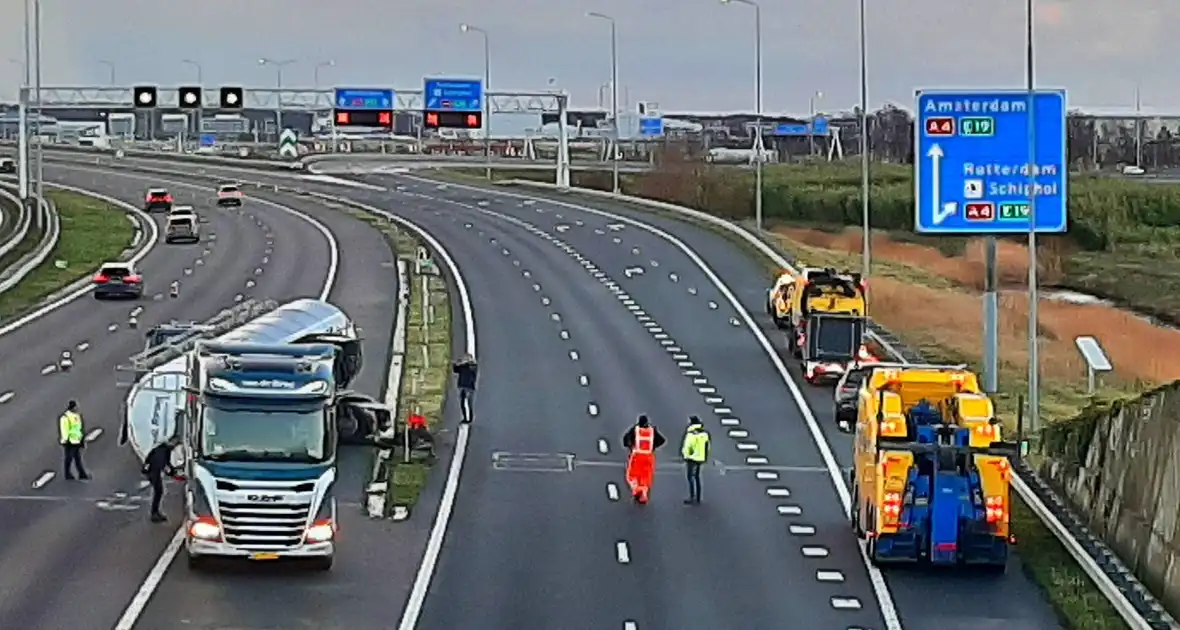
[0,165,415,629]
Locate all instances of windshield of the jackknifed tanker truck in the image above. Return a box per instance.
[201,405,332,464]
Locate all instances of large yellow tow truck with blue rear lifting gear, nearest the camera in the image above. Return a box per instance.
[850,365,1016,571]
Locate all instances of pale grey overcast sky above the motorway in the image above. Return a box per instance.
[0,0,1180,113]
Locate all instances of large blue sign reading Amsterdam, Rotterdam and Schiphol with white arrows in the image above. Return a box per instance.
[913,90,1069,234]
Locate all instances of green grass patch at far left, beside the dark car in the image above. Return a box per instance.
[0,191,135,320]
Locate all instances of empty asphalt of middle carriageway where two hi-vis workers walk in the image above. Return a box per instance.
[332,183,880,630]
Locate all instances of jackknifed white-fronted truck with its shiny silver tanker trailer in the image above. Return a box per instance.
[120,300,392,569]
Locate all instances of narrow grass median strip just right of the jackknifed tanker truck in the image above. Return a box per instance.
[386,231,451,510]
